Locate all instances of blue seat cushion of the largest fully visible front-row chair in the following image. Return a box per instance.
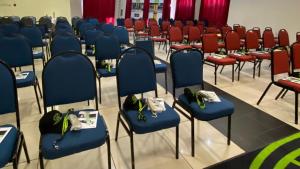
[41,111,107,160]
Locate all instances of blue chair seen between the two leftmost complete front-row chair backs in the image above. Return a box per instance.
[95,35,121,103]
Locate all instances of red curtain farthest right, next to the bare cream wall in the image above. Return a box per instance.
[199,0,230,27]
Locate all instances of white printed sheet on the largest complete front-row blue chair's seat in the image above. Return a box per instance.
[78,111,98,129]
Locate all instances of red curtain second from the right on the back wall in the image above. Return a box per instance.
[175,0,195,20]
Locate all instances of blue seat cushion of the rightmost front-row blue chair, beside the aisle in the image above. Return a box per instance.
[178,94,234,121]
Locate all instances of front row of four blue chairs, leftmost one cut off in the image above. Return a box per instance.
[0,47,234,169]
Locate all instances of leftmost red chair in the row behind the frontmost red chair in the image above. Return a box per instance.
[225,31,256,80]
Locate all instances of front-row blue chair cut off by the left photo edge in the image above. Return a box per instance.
[0,60,30,169]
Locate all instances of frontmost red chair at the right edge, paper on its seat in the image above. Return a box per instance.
[257,47,300,124]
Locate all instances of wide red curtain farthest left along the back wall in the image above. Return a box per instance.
[83,0,115,24]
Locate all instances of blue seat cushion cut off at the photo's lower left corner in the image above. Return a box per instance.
[0,125,19,168]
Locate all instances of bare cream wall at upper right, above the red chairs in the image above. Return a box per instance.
[228,0,300,43]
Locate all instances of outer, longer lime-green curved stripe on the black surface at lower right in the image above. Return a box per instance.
[249,133,300,169]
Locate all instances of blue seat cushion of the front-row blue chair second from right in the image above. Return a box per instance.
[124,104,180,134]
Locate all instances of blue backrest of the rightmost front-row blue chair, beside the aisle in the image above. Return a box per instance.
[170,49,203,88]
